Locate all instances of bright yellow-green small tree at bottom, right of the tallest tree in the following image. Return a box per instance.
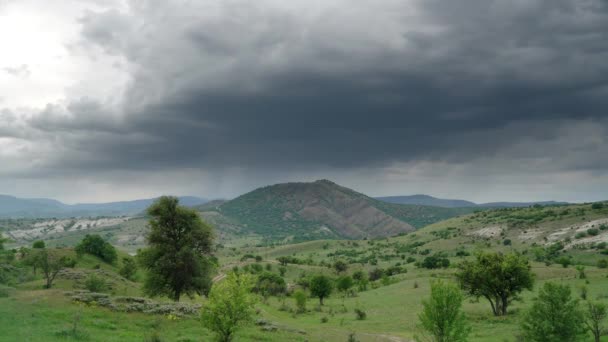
[201,273,255,342]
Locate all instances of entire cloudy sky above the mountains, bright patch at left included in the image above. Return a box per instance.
[0,0,608,203]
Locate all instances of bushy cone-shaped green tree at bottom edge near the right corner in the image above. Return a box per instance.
[521,282,585,342]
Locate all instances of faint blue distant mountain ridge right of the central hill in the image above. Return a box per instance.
[376,194,569,208]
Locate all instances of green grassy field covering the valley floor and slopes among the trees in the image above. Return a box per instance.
[0,205,608,342]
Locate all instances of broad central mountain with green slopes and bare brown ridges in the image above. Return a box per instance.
[209,180,480,240]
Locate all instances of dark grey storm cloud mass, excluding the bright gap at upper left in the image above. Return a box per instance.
[16,0,608,176]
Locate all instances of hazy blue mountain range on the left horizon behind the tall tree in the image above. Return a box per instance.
[0,195,207,218]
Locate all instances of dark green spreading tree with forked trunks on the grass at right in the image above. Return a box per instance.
[456,252,534,316]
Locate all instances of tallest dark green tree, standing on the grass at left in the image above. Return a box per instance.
[139,196,214,301]
